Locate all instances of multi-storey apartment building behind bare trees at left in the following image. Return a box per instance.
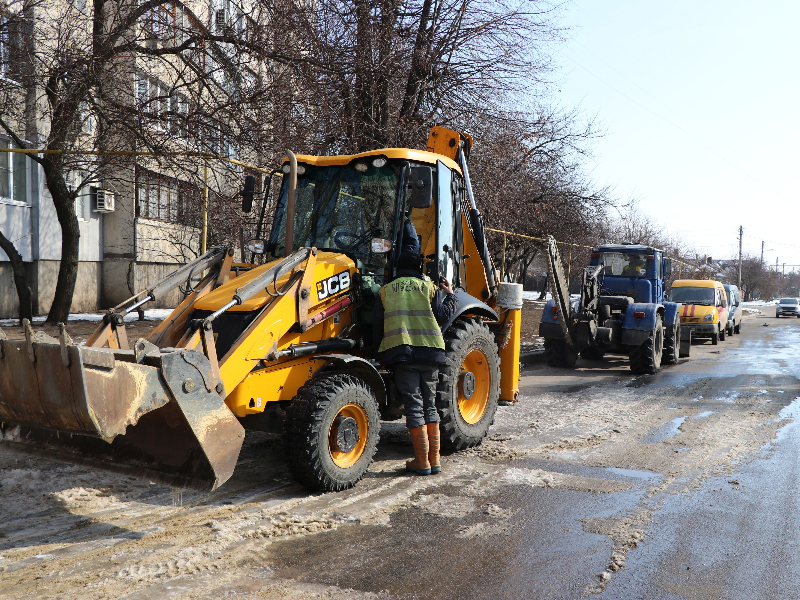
[0,0,257,318]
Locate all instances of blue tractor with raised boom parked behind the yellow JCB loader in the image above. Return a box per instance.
[539,236,691,374]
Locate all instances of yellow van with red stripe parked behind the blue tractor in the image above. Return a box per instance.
[669,279,728,345]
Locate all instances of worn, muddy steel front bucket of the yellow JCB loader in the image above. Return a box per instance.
[0,334,244,490]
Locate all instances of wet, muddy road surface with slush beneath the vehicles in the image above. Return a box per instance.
[0,312,800,600]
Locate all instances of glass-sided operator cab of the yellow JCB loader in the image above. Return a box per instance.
[264,150,465,287]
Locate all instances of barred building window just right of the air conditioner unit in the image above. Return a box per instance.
[136,167,199,225]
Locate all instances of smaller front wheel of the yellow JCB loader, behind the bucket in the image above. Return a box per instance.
[283,373,381,492]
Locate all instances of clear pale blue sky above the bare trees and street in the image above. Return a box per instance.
[555,0,800,272]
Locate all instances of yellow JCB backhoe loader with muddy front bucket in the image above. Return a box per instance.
[0,127,522,491]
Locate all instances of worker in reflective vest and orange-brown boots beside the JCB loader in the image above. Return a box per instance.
[373,219,457,475]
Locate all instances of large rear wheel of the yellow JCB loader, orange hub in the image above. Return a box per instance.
[436,318,500,450]
